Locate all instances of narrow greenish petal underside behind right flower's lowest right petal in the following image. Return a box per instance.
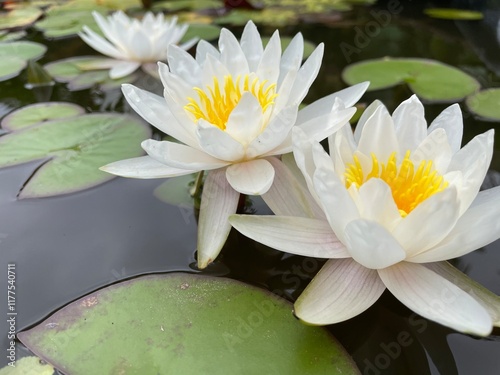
[424,262,500,327]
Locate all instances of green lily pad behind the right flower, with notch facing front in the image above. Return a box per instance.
[342,57,480,103]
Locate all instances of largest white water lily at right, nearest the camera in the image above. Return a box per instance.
[230,96,500,335]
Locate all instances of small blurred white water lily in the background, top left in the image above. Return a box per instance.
[78,11,198,79]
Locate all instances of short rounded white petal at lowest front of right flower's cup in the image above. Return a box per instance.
[345,219,406,269]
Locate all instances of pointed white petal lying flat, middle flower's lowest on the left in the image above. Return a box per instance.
[99,156,196,179]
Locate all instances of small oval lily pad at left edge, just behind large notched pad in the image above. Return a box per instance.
[1,102,85,131]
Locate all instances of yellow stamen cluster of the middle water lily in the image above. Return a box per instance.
[184,74,278,130]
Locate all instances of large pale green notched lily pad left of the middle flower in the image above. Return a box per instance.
[0,113,151,198]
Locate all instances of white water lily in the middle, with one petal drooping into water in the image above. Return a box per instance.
[102,22,367,268]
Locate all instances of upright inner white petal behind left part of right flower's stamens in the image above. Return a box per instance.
[358,106,400,162]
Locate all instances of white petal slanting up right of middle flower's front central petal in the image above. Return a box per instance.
[247,106,298,158]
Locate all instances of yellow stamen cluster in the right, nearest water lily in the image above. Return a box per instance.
[344,151,448,217]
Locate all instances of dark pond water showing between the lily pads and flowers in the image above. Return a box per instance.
[0,2,500,375]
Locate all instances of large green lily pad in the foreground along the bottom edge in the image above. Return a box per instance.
[18,273,359,375]
